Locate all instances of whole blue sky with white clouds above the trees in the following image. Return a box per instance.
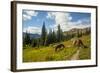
[22,10,91,34]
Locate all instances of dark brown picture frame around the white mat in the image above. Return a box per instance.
[11,1,98,72]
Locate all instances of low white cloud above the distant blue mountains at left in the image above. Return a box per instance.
[23,26,41,34]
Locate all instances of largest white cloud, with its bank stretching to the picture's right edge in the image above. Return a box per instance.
[47,12,90,31]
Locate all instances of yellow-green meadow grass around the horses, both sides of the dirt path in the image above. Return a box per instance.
[23,35,91,62]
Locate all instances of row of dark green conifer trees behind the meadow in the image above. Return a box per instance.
[23,22,90,48]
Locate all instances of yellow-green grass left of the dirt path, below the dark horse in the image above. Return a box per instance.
[23,47,77,62]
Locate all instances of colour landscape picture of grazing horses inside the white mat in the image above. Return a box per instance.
[22,9,92,62]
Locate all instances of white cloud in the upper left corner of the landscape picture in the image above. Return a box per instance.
[23,10,38,20]
